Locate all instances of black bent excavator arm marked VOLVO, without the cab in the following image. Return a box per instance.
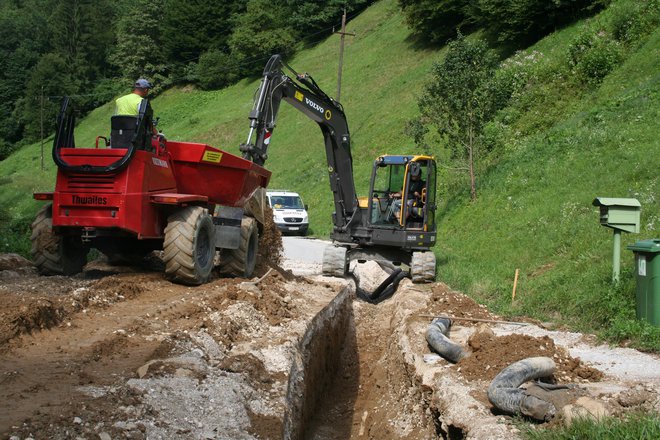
[240,55,359,232]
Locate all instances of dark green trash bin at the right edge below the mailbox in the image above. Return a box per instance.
[628,238,660,327]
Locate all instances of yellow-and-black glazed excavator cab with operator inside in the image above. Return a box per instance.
[368,156,436,231]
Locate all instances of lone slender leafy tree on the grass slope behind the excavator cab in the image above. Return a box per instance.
[411,33,497,200]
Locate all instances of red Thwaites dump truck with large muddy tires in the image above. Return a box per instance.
[31,98,270,285]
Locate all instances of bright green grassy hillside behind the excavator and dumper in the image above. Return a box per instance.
[0,0,660,350]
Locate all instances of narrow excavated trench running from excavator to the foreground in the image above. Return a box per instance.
[284,262,442,440]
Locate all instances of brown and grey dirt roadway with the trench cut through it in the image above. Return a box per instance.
[0,246,660,440]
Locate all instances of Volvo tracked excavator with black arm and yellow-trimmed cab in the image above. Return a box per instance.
[241,55,436,282]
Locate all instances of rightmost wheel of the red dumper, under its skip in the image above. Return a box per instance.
[219,217,259,278]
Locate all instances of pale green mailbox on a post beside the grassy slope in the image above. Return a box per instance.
[593,197,642,282]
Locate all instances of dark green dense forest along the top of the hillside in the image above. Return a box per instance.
[0,0,607,160]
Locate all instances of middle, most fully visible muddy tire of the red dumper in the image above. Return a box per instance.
[163,206,215,286]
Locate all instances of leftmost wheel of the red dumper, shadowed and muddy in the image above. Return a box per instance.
[30,204,89,275]
